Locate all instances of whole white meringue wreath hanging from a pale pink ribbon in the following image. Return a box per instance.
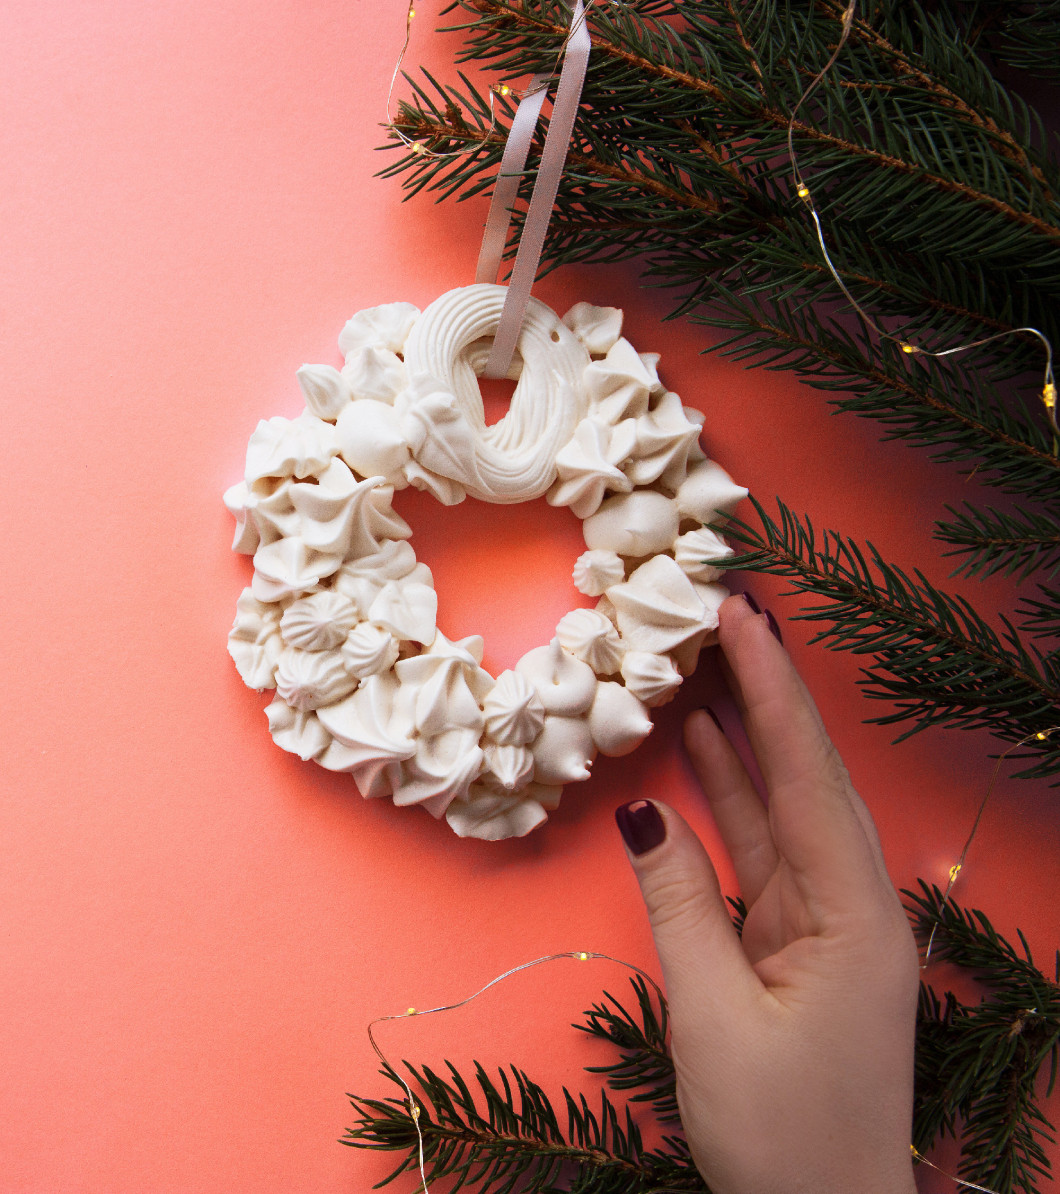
[224,285,746,841]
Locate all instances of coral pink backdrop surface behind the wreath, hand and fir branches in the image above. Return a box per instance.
[0,0,1060,1194]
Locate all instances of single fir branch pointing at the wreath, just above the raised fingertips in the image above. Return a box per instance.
[723,499,1060,777]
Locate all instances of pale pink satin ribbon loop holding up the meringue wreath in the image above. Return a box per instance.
[475,0,592,377]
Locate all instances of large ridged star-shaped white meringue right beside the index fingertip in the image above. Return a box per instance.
[608,555,717,654]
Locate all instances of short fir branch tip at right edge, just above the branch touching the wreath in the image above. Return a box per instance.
[936,503,1060,580]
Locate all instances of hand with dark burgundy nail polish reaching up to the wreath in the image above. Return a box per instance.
[616,597,918,1194]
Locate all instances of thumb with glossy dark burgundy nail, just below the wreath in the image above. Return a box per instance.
[615,800,763,1023]
